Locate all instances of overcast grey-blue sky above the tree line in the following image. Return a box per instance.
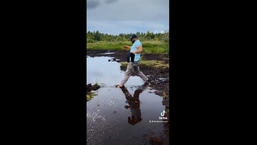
[87,0,169,35]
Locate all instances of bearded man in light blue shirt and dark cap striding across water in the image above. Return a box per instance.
[116,34,148,88]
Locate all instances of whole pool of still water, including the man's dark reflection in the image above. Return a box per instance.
[87,56,167,145]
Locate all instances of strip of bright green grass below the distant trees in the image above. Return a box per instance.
[86,40,169,54]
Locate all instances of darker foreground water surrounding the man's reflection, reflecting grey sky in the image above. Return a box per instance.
[87,87,165,145]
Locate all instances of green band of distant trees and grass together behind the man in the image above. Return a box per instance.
[86,31,169,54]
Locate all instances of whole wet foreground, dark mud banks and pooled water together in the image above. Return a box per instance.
[87,51,169,145]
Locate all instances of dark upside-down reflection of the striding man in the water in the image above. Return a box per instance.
[117,83,149,125]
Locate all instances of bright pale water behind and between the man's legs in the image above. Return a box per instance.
[86,57,143,86]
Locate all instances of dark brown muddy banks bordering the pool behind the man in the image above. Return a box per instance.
[87,50,169,96]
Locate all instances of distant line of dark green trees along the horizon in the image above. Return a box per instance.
[87,31,169,43]
